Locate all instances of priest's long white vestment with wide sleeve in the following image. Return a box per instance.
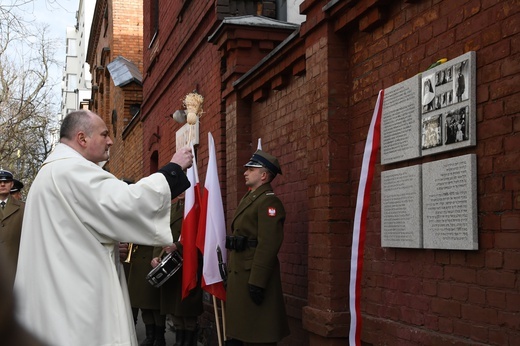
[15,144,177,346]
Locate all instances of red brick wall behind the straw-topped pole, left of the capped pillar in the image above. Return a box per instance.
[143,2,225,176]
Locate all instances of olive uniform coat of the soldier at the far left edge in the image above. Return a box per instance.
[0,197,25,287]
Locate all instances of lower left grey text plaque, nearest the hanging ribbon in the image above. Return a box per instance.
[381,165,422,248]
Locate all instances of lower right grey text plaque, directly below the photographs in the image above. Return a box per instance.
[422,154,478,250]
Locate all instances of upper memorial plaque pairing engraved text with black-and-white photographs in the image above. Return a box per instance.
[381,52,477,165]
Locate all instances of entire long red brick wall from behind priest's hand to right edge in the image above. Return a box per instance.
[89,0,520,345]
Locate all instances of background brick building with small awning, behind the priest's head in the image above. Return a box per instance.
[87,0,143,182]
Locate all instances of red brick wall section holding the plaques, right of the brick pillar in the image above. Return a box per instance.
[298,1,520,345]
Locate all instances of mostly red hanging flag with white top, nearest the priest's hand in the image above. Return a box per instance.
[181,145,200,299]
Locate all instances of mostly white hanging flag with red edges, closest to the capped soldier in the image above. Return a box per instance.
[197,133,226,300]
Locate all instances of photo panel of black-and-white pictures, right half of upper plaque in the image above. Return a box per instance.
[421,52,477,156]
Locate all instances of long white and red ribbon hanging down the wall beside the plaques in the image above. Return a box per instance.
[349,90,384,346]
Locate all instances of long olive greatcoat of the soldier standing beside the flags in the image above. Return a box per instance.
[226,184,289,343]
